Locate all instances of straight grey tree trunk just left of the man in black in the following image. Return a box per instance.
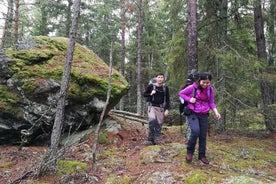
[137,0,143,114]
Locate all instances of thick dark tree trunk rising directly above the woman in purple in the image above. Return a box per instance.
[188,0,198,74]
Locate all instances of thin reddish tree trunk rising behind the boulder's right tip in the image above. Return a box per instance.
[119,0,126,110]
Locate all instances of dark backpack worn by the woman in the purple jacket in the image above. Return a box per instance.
[179,73,198,115]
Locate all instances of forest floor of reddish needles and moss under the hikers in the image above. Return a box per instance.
[0,114,276,184]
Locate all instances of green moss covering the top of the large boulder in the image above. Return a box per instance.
[2,36,129,104]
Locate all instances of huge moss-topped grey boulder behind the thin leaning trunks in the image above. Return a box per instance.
[0,37,129,144]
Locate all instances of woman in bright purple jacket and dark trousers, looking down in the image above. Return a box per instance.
[179,72,221,164]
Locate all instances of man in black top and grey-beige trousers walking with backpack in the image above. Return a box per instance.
[144,73,170,145]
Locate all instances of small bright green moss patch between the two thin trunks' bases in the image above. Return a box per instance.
[57,160,87,176]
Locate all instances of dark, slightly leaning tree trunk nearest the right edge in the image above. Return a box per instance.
[254,0,276,132]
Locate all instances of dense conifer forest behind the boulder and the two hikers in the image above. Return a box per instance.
[0,0,276,132]
